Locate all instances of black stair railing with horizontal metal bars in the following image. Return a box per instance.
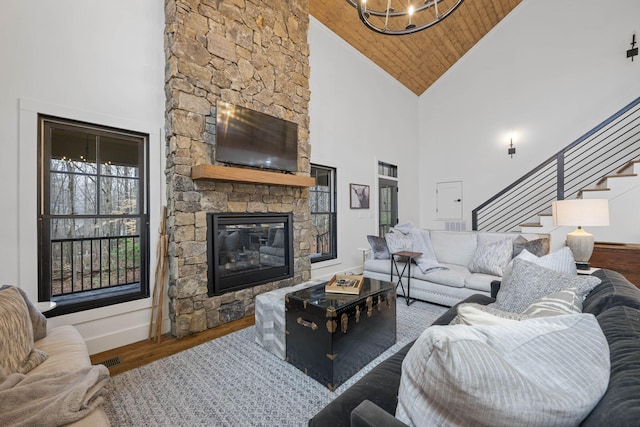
[471,97,640,232]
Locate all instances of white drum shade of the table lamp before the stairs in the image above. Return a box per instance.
[551,199,609,227]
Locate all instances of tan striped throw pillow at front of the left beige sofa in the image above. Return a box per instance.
[0,287,47,375]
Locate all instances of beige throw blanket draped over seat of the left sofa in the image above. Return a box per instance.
[0,365,111,427]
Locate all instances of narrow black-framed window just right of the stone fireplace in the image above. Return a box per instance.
[309,165,337,262]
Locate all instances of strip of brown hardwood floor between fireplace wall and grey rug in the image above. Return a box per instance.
[91,316,255,375]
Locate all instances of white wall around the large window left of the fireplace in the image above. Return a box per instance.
[0,0,166,353]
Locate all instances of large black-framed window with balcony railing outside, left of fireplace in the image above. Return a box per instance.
[38,116,149,315]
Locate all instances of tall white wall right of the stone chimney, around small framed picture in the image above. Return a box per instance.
[309,17,419,278]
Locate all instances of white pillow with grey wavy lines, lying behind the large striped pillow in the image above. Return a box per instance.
[450,288,582,326]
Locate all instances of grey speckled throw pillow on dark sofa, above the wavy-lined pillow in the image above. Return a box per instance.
[491,258,600,313]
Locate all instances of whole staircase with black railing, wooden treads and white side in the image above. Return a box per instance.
[472,98,640,247]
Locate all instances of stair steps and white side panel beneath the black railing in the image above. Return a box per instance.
[520,160,640,250]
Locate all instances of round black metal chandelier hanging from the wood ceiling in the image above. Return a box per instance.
[347,0,463,36]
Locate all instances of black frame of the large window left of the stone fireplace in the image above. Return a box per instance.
[37,114,150,317]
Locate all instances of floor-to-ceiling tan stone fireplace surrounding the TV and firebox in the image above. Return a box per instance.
[165,0,311,337]
